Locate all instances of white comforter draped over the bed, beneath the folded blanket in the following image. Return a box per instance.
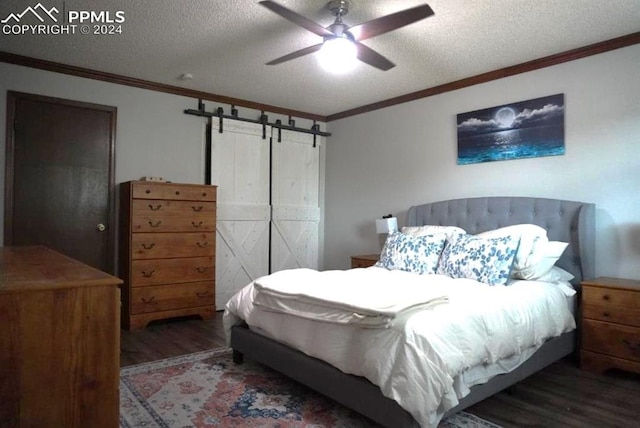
[224,267,575,427]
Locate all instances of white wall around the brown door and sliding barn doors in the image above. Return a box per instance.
[0,62,326,263]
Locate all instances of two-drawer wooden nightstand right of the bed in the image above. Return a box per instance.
[580,277,640,373]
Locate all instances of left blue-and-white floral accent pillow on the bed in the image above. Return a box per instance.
[375,232,447,275]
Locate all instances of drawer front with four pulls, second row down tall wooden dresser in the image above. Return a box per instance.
[131,199,216,232]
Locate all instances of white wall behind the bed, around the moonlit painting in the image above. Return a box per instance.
[325,45,640,278]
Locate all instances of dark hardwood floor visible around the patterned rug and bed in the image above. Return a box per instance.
[120,312,640,428]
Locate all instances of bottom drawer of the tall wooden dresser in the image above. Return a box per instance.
[131,281,215,314]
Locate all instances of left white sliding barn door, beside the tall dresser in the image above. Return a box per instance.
[211,120,271,310]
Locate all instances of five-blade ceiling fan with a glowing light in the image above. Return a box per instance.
[260,0,434,71]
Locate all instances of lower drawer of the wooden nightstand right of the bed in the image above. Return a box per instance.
[582,319,640,362]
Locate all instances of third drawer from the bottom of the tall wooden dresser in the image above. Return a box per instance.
[131,232,216,260]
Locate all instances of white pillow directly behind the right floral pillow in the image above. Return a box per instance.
[475,224,549,270]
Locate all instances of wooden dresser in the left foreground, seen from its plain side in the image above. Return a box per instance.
[0,247,122,428]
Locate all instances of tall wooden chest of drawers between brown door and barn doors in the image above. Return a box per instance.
[119,181,216,329]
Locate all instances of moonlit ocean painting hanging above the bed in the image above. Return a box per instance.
[458,94,564,165]
